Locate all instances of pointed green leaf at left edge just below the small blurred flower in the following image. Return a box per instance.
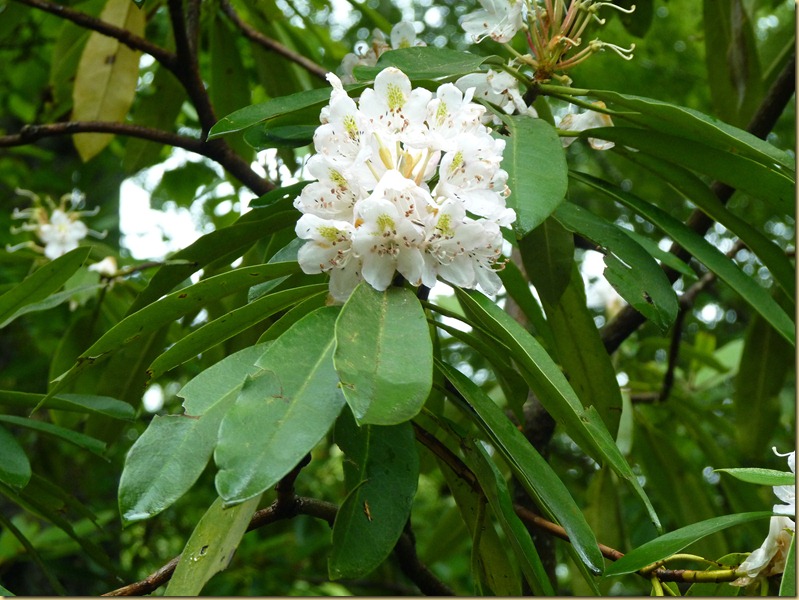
[0,247,91,329]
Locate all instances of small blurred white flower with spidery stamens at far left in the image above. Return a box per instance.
[6,189,105,260]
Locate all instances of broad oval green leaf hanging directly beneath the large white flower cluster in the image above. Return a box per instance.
[333,282,433,425]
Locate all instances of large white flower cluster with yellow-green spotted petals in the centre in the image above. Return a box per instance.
[294,68,516,302]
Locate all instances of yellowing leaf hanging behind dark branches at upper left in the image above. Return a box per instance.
[72,0,144,162]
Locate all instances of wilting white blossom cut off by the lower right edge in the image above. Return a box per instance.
[732,448,796,586]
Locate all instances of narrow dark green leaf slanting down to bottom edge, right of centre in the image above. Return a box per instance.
[464,440,555,596]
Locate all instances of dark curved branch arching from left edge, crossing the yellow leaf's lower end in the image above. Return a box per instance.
[0,121,275,195]
